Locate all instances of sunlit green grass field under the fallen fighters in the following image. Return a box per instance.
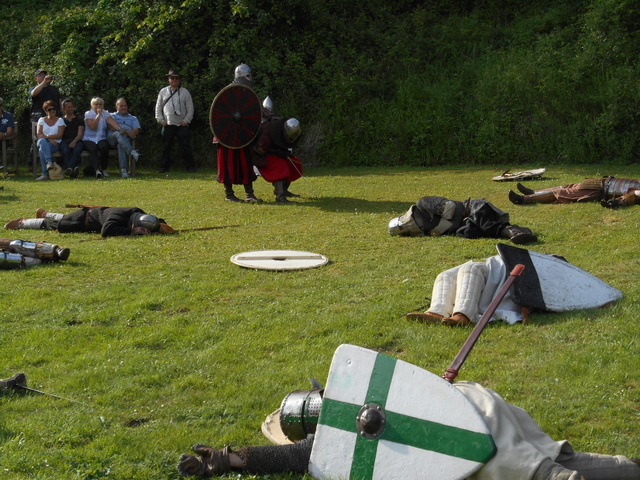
[0,165,640,480]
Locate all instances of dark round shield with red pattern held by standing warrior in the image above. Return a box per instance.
[209,84,262,149]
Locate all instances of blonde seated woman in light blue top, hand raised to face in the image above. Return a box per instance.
[82,97,120,178]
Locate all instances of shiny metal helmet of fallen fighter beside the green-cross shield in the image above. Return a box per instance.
[280,388,324,442]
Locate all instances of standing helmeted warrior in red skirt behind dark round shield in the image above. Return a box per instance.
[213,63,262,203]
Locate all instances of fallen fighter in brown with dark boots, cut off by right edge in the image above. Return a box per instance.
[509,176,640,208]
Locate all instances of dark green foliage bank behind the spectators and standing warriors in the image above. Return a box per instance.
[0,0,640,165]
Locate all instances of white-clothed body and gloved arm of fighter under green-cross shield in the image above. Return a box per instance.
[178,382,640,480]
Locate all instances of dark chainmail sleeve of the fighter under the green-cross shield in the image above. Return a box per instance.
[234,437,313,475]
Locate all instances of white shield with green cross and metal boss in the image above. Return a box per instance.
[309,345,496,480]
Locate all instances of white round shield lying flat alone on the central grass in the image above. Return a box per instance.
[231,250,329,270]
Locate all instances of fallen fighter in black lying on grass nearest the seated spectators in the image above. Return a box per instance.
[4,206,175,237]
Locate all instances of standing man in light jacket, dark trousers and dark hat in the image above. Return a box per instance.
[156,69,196,173]
